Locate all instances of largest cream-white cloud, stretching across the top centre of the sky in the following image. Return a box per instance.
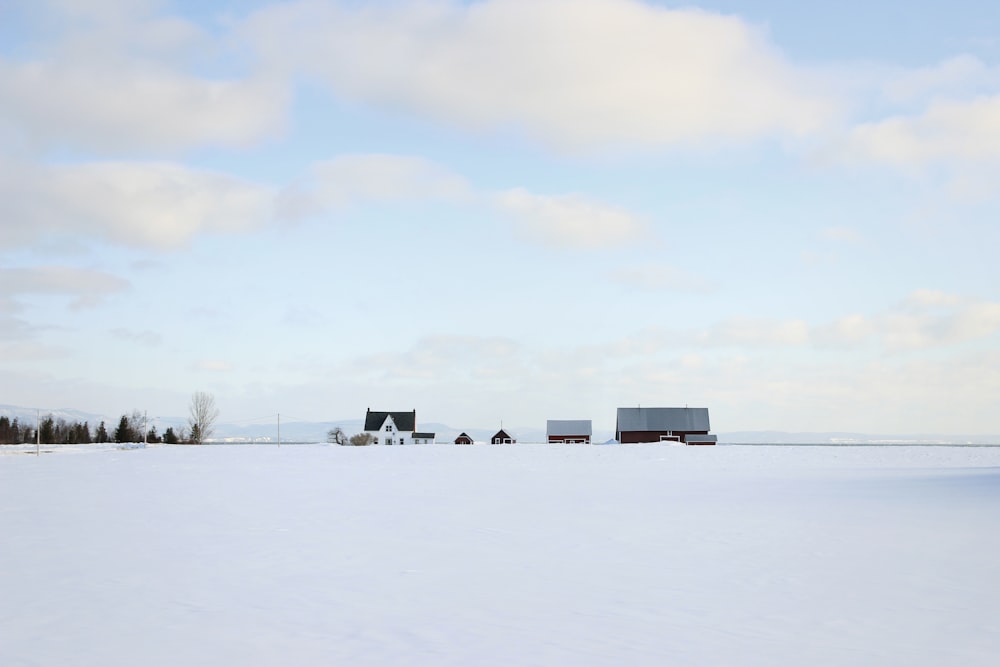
[240,0,837,150]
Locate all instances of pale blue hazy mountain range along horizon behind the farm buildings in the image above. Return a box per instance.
[0,405,1000,445]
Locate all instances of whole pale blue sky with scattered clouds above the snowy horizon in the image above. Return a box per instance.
[0,0,1000,435]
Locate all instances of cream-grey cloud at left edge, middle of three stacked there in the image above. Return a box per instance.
[0,162,274,249]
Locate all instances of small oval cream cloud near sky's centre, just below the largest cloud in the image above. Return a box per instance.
[494,188,646,248]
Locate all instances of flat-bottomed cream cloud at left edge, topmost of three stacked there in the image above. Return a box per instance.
[0,60,288,153]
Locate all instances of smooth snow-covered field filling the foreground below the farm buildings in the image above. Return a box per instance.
[0,445,1000,667]
